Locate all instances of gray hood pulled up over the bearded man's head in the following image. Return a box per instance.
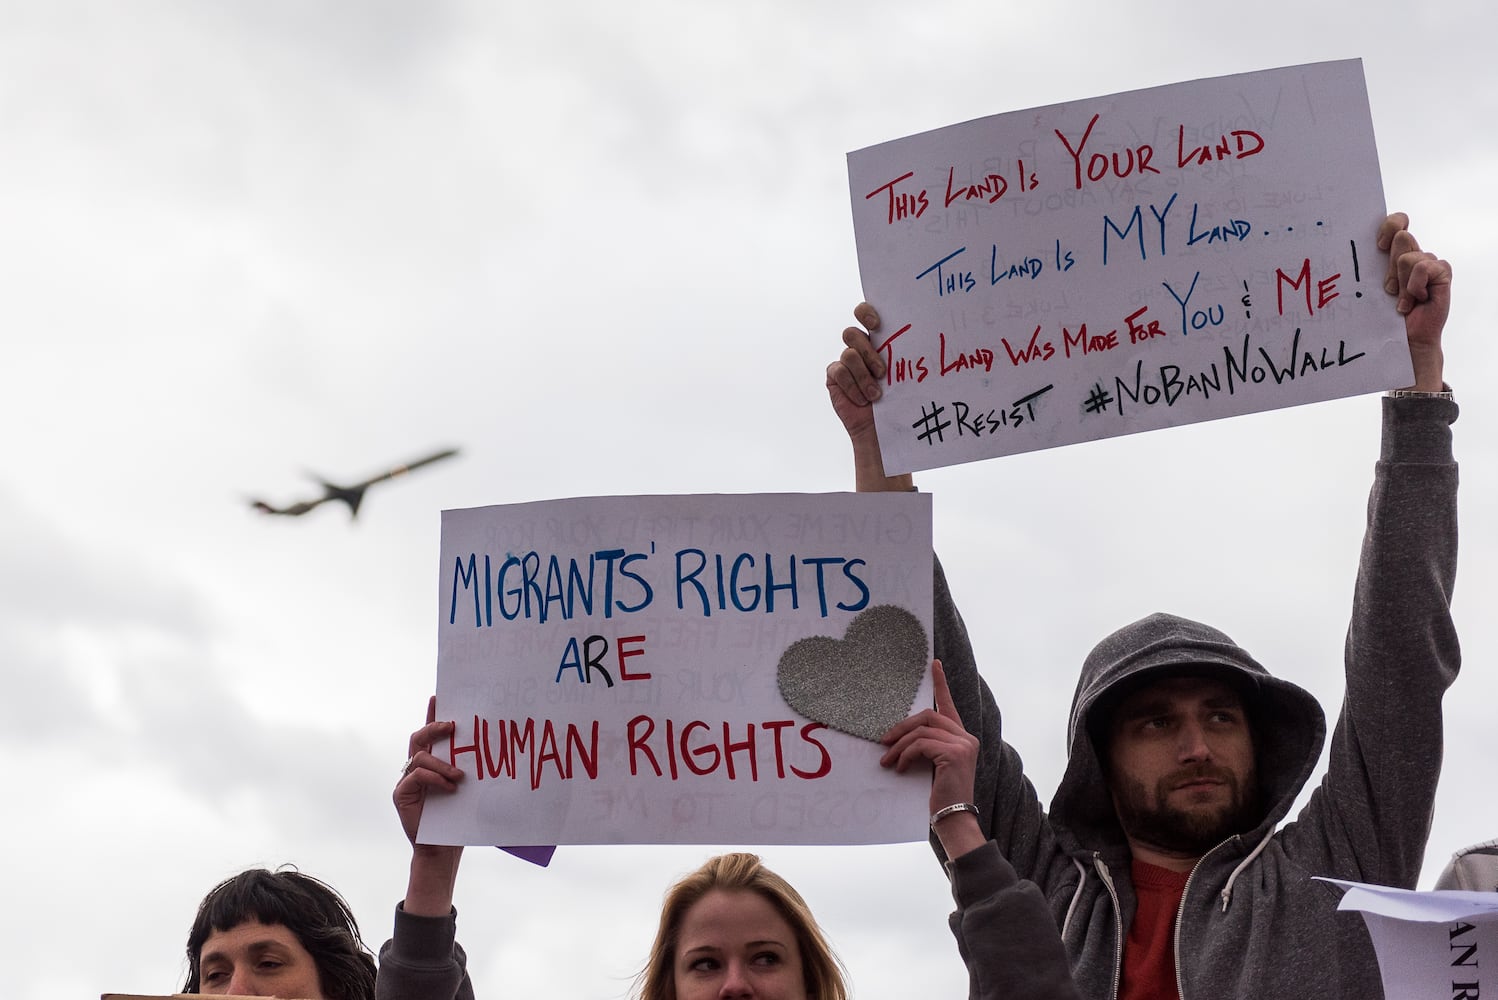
[1050,612,1326,849]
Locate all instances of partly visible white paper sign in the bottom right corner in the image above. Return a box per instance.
[1323,879,1498,1000]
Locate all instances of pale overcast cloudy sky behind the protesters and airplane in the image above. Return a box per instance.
[0,0,1498,1000]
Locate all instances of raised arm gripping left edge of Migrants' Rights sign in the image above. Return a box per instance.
[375,698,473,1000]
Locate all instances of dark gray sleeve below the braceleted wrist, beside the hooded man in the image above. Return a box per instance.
[948,840,1079,1000]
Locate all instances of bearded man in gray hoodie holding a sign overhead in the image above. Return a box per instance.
[827,214,1461,1000]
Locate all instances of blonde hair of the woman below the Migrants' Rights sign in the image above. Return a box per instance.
[637,853,848,1000]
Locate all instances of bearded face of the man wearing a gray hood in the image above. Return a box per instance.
[1109,677,1258,859]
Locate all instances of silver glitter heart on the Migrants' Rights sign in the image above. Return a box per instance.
[776,605,927,743]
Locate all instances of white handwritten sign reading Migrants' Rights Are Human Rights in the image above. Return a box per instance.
[421,493,932,844]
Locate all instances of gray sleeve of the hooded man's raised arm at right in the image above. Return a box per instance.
[1291,398,1461,888]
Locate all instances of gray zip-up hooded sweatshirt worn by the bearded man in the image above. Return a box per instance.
[933,398,1461,1000]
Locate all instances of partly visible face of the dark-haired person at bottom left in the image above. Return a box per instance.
[198,921,322,1000]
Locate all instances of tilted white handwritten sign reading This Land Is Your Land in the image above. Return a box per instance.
[848,60,1413,472]
